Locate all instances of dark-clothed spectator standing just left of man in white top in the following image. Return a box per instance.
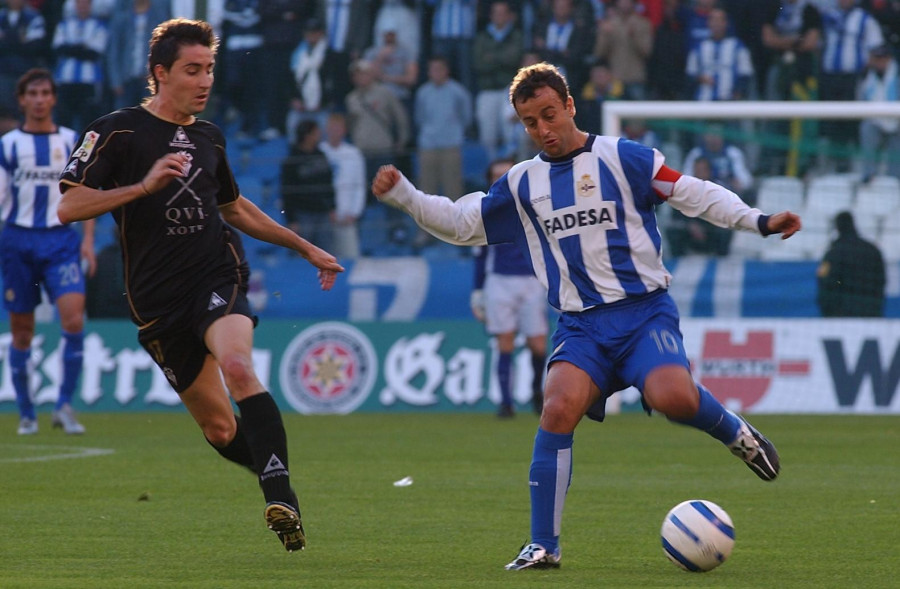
[281,119,335,251]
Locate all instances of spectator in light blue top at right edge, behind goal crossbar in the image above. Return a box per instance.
[859,45,900,182]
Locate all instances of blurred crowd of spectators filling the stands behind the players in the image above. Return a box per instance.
[0,0,900,256]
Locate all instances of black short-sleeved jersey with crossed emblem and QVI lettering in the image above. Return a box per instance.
[60,107,249,325]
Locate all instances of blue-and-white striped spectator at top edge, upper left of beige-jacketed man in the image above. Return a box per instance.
[316,0,375,106]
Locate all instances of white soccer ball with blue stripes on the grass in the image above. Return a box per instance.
[660,499,734,573]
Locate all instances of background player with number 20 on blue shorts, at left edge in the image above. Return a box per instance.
[0,69,97,435]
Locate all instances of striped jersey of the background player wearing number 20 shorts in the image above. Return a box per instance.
[0,127,76,228]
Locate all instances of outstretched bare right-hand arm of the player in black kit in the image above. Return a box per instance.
[219,196,344,290]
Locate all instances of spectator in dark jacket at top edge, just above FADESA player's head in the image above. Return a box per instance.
[534,0,594,97]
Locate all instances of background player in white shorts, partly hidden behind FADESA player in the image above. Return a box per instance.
[470,160,548,417]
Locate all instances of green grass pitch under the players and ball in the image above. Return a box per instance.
[0,412,900,589]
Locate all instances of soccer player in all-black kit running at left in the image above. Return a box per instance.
[58,19,343,551]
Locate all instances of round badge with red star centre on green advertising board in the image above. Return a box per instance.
[278,322,378,413]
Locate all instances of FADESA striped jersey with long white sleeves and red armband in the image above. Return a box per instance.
[382,135,767,312]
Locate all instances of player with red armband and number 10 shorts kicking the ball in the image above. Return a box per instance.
[372,63,801,570]
